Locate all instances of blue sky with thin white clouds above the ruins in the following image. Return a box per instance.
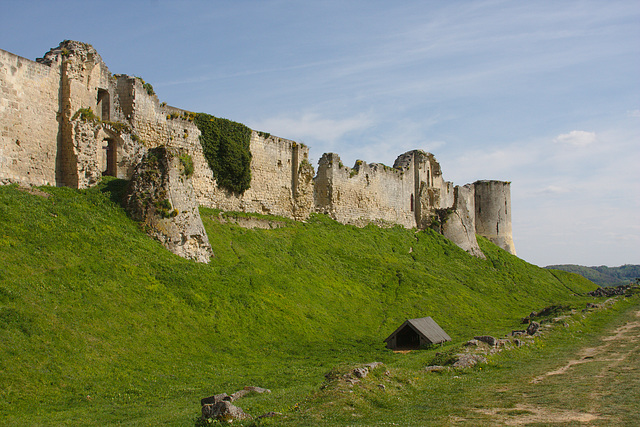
[0,0,640,266]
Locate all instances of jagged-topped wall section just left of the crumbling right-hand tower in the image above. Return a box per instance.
[315,153,416,228]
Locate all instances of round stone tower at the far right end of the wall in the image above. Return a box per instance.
[473,181,516,255]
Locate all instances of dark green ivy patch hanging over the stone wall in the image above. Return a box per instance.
[194,113,251,194]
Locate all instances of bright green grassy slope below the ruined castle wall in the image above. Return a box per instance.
[0,181,595,425]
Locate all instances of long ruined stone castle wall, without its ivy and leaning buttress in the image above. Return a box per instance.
[0,40,515,256]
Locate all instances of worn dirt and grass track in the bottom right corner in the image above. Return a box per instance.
[458,310,640,426]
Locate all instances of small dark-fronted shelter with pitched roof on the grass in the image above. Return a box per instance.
[384,317,451,350]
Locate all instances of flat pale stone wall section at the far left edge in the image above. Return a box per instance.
[0,50,60,185]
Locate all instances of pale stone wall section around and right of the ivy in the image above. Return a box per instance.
[192,131,313,219]
